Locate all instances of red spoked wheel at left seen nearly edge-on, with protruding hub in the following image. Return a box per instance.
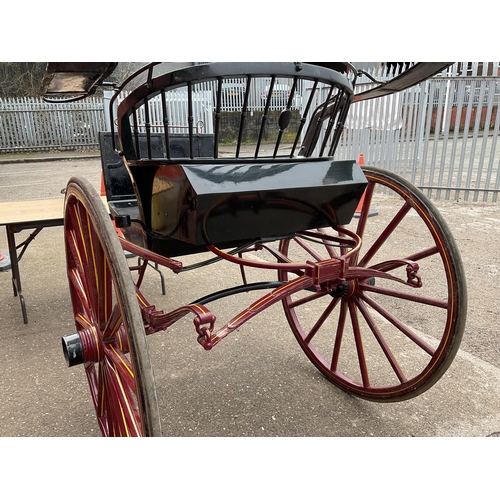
[63,178,161,436]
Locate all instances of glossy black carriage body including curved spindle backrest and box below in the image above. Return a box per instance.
[107,63,366,257]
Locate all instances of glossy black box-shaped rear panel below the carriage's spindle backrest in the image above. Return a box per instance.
[130,161,366,249]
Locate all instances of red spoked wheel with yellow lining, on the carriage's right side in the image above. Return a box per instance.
[279,167,467,401]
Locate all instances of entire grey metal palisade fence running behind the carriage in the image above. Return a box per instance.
[0,62,500,202]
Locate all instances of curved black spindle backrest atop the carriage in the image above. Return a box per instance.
[110,63,355,162]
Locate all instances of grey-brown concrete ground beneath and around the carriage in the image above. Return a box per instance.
[0,150,500,437]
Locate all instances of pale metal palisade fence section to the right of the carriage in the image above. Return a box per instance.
[337,63,500,202]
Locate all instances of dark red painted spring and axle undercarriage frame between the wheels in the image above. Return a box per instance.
[120,226,420,350]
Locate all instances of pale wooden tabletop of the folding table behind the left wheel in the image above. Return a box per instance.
[0,197,107,225]
